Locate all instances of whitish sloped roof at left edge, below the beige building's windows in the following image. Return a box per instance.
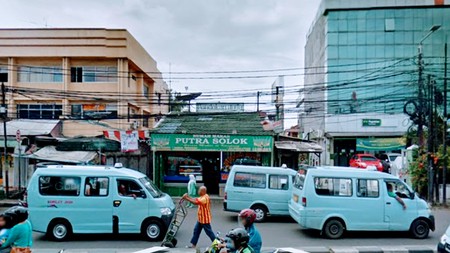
[0,119,60,136]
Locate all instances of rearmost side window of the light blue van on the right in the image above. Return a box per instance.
[314,177,352,197]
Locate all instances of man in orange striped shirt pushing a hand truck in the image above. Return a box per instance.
[183,186,216,248]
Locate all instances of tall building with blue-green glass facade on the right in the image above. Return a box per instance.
[298,0,450,165]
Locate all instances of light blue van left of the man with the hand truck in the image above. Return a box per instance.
[28,164,175,241]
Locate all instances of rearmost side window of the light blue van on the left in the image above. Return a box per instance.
[39,176,81,196]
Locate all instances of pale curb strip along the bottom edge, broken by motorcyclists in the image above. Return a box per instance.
[29,245,436,253]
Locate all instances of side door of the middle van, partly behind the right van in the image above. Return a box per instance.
[266,175,292,215]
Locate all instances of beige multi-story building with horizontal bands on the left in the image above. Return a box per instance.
[0,29,168,137]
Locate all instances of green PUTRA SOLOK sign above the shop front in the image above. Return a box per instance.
[151,134,273,152]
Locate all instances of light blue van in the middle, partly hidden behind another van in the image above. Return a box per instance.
[223,165,296,222]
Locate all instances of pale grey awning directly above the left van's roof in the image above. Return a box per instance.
[28,146,97,164]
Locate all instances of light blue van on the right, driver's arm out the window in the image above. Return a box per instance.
[289,167,435,239]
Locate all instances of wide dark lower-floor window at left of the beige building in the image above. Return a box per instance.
[17,104,62,119]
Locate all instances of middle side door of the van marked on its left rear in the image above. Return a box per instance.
[77,177,114,233]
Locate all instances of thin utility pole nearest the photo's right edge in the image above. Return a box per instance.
[442,41,448,206]
